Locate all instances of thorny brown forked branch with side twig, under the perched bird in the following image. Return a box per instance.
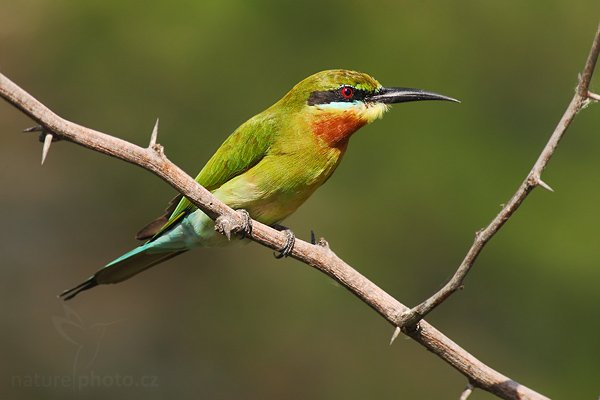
[0,26,600,400]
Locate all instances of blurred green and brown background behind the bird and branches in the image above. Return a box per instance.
[0,0,600,399]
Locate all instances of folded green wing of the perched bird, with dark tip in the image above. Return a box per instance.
[136,114,276,240]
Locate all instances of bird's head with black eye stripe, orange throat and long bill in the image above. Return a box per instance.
[280,69,458,146]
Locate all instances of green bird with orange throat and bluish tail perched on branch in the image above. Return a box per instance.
[59,69,459,300]
